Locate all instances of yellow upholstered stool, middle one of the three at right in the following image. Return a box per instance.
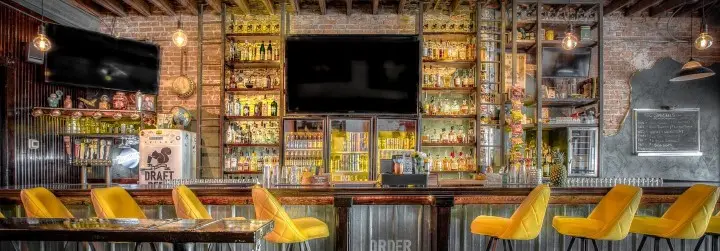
[553,185,642,251]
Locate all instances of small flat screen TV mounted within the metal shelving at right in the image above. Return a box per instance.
[542,48,592,77]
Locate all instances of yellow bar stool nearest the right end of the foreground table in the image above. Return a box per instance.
[252,186,330,250]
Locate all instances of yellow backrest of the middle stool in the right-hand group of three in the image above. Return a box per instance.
[588,185,642,240]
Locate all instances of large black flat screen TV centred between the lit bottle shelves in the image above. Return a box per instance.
[286,35,420,114]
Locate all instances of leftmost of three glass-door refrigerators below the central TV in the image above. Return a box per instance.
[283,118,325,173]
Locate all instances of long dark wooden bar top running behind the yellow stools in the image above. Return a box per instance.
[0,183,704,205]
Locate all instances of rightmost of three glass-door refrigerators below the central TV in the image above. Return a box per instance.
[375,119,417,177]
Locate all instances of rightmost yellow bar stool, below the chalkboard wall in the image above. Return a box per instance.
[630,184,718,251]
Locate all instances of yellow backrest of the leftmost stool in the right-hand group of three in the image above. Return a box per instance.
[501,184,550,240]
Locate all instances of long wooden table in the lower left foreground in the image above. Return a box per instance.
[0,218,273,250]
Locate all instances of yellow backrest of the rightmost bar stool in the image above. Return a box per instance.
[662,184,719,239]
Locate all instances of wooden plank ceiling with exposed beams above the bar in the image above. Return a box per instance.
[67,0,720,17]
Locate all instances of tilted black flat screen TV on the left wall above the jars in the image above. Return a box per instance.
[45,24,160,94]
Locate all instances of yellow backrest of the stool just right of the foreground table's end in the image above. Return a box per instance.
[252,186,307,243]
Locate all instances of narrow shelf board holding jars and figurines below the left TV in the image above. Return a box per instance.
[32,107,155,120]
